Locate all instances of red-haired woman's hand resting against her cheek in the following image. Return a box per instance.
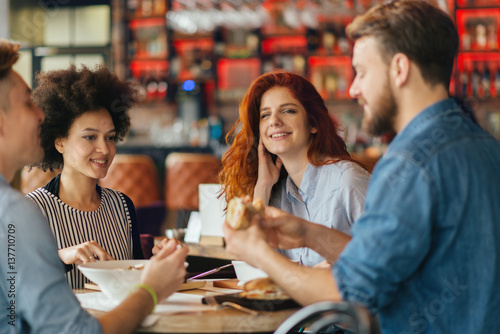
[253,138,283,204]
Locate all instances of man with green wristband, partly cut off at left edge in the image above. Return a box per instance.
[0,40,188,333]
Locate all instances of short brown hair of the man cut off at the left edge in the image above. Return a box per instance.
[0,39,19,110]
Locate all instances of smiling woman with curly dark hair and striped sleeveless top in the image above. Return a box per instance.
[27,66,143,288]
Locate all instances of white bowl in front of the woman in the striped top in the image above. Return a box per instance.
[78,260,149,302]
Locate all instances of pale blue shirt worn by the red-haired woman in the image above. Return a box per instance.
[269,161,370,266]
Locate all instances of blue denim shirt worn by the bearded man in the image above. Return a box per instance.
[332,99,500,334]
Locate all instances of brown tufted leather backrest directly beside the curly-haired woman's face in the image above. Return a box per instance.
[99,154,160,208]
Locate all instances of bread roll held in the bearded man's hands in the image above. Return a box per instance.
[226,196,264,230]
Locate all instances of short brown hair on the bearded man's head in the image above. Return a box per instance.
[346,0,458,87]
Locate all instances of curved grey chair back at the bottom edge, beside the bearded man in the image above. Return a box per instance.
[274,301,381,334]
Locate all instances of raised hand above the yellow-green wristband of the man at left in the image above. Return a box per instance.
[141,239,189,302]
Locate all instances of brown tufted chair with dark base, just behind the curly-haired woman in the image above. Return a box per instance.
[99,154,166,235]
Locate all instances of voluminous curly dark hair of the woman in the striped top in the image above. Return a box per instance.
[32,65,141,171]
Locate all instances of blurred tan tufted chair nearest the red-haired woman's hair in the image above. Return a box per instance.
[165,153,222,228]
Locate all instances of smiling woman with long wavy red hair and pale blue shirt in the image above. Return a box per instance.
[219,71,370,266]
